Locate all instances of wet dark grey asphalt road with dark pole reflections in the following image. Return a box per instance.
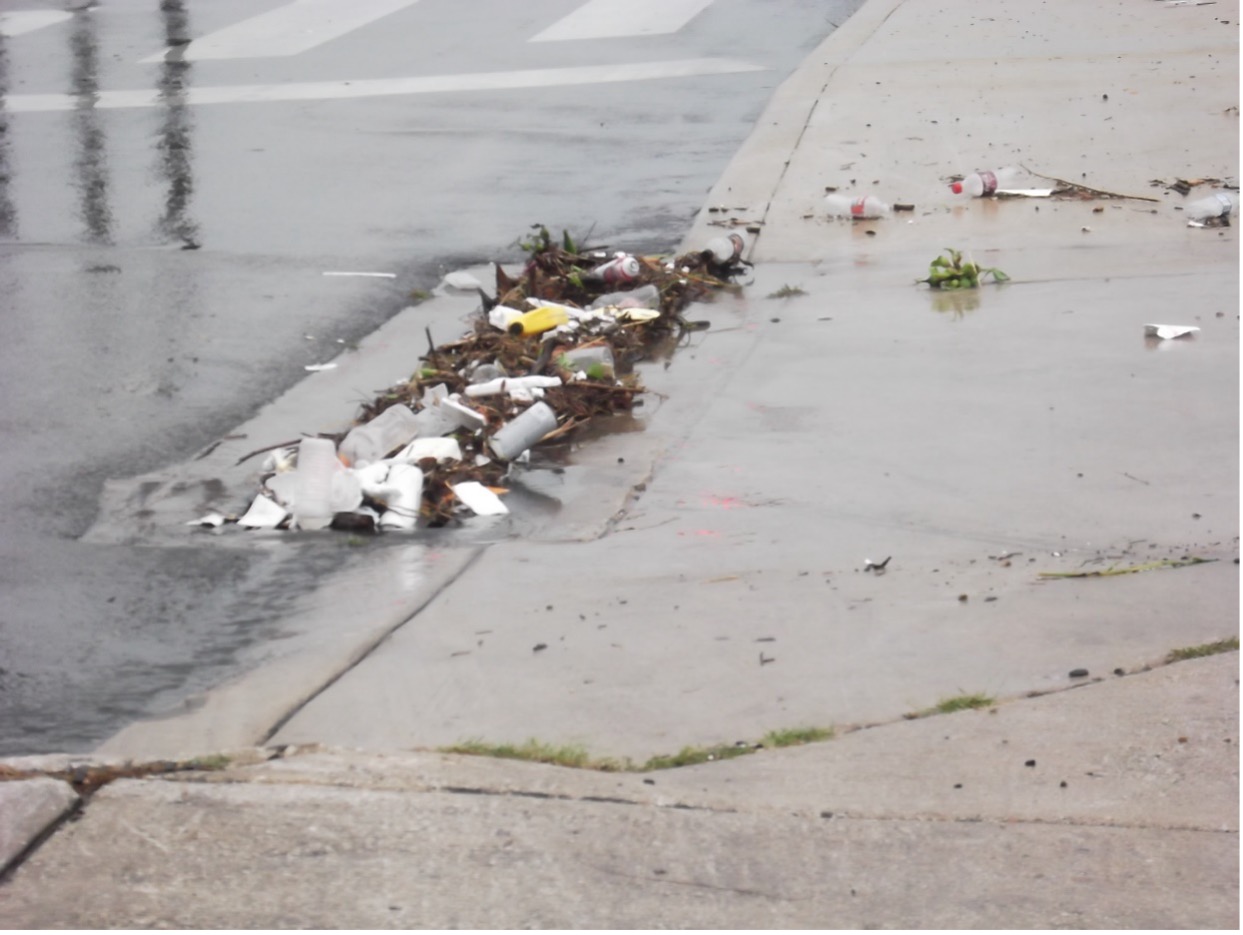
[0,0,858,753]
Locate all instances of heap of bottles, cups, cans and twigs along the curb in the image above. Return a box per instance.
[186,225,750,532]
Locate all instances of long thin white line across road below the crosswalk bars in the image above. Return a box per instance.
[5,58,766,113]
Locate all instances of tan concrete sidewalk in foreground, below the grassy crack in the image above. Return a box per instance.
[0,654,1238,929]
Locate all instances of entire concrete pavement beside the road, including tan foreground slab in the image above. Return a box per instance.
[0,0,1239,928]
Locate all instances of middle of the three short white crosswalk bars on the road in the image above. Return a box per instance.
[142,0,418,63]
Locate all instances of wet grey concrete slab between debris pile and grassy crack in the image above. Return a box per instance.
[262,254,1238,761]
